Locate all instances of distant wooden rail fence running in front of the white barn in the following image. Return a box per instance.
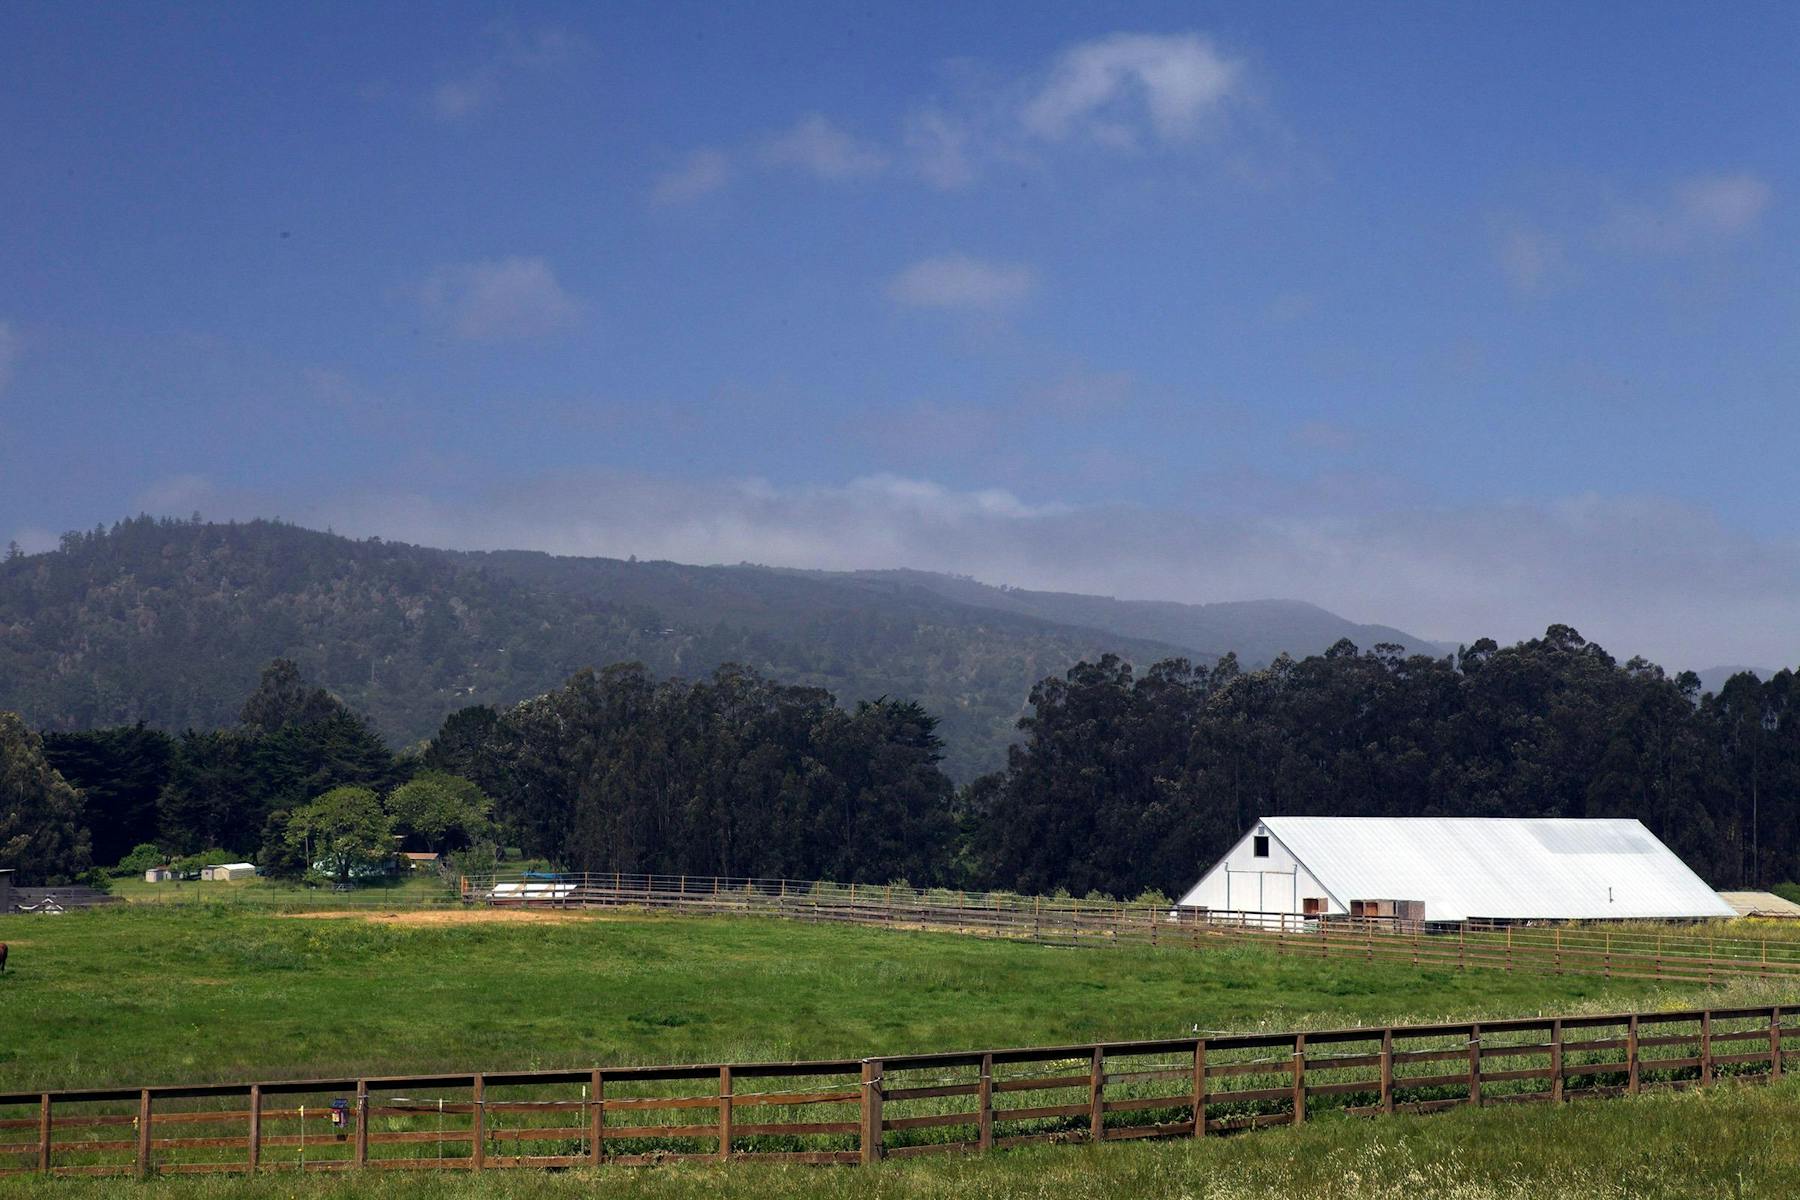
[457,871,1800,984]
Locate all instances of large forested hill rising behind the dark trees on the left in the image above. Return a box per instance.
[0,518,1179,779]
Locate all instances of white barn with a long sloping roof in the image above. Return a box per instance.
[1177,817,1733,921]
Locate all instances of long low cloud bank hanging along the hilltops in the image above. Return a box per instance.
[221,473,1800,669]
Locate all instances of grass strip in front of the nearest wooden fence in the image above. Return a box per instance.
[0,1081,1800,1200]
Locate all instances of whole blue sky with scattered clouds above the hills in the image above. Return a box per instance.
[0,4,1800,666]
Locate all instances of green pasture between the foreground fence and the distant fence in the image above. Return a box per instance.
[0,903,1800,1090]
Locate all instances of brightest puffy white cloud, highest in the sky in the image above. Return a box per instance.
[1021,32,1246,144]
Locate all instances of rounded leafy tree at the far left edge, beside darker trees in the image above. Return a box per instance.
[0,712,94,885]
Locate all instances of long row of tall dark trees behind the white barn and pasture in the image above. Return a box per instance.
[10,626,1800,896]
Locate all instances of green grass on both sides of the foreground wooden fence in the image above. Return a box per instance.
[0,906,1800,1198]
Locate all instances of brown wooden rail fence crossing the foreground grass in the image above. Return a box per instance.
[0,1007,1800,1175]
